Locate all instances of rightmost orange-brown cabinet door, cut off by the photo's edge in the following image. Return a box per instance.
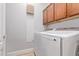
[67,3,79,16]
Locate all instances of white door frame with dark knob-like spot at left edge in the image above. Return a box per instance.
[0,3,6,56]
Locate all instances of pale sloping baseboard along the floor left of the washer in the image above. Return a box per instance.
[7,48,34,56]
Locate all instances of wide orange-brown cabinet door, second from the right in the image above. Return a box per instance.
[55,3,66,20]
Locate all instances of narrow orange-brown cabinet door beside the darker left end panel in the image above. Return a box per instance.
[47,4,54,22]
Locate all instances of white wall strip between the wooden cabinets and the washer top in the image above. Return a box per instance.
[48,18,79,29]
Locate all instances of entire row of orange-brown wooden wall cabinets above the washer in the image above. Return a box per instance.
[43,3,79,24]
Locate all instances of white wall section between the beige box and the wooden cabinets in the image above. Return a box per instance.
[34,3,48,32]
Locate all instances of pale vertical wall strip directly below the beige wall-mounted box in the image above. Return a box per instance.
[26,6,34,42]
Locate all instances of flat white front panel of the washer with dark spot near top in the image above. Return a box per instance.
[42,35,60,56]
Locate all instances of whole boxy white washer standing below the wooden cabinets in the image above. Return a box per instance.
[34,31,79,56]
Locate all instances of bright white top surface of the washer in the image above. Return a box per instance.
[40,30,79,37]
